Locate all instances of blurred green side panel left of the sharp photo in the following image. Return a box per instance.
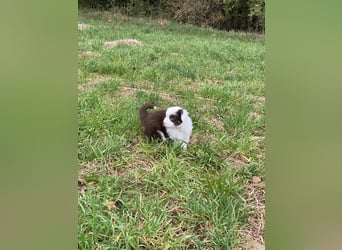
[0,1,77,249]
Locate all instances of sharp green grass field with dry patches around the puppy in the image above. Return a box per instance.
[78,9,265,249]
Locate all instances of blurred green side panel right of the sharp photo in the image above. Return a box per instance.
[266,1,342,249]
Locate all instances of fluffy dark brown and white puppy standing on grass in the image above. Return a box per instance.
[140,103,192,149]
